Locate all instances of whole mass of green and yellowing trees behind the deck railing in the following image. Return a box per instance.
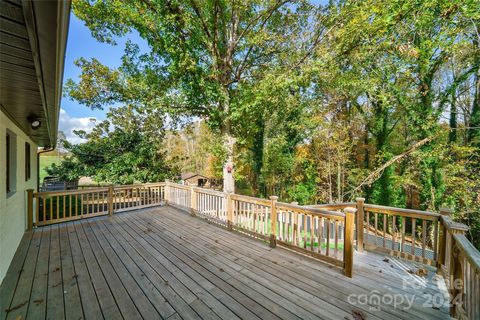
[52,0,480,247]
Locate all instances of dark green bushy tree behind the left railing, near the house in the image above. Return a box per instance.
[48,107,178,184]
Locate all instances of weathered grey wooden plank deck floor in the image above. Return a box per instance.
[0,207,449,320]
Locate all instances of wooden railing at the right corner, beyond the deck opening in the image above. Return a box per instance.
[311,198,480,319]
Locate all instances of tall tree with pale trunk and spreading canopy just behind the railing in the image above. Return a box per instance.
[68,0,318,191]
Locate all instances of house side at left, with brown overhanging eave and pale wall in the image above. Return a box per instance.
[0,0,70,281]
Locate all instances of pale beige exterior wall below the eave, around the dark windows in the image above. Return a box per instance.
[0,110,38,282]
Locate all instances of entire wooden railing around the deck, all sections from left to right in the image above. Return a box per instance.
[28,181,480,319]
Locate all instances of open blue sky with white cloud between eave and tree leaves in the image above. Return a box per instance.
[59,13,147,142]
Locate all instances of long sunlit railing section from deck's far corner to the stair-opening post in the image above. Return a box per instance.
[165,182,356,277]
